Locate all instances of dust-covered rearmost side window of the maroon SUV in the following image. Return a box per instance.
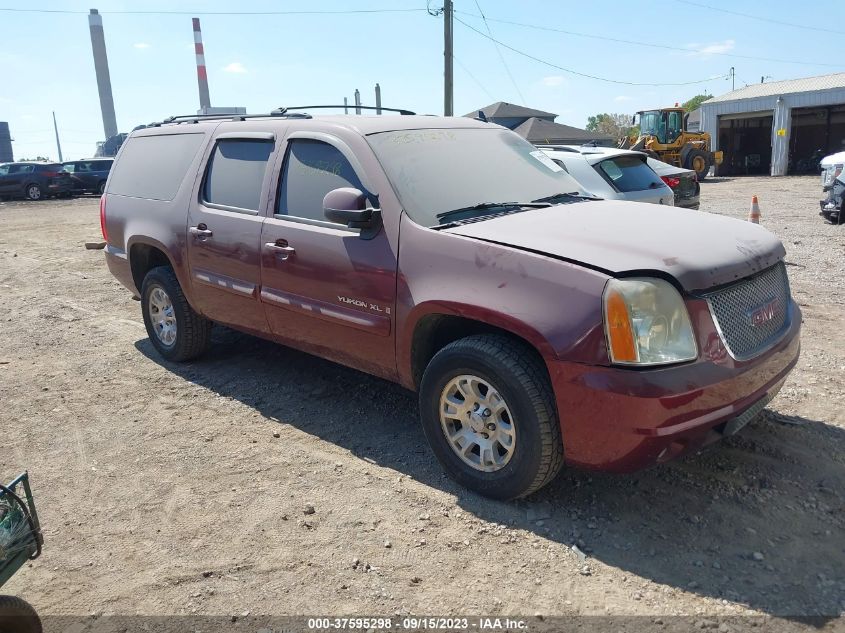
[109,134,205,200]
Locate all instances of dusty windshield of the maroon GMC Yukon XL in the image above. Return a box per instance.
[367,128,582,226]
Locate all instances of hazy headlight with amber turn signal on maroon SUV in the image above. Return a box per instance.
[604,277,698,365]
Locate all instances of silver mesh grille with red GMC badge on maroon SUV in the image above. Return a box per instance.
[704,262,791,360]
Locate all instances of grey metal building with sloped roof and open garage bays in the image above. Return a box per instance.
[701,73,845,176]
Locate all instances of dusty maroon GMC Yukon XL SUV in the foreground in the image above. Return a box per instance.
[100,110,801,499]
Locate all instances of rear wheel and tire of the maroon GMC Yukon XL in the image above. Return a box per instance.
[141,266,211,362]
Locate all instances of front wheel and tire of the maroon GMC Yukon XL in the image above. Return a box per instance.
[419,334,563,501]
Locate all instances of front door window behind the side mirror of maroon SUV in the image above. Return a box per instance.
[276,139,364,222]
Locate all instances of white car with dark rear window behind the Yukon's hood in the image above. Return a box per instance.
[538,145,675,206]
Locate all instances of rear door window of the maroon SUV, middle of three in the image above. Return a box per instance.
[203,139,274,211]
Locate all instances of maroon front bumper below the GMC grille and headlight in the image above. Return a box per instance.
[548,302,801,472]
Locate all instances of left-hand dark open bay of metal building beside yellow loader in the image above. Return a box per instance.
[718,112,773,176]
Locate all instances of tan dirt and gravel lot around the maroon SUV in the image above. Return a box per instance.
[0,177,845,616]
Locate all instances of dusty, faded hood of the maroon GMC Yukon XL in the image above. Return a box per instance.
[444,200,786,291]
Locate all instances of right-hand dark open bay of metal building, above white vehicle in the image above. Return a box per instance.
[787,106,845,174]
